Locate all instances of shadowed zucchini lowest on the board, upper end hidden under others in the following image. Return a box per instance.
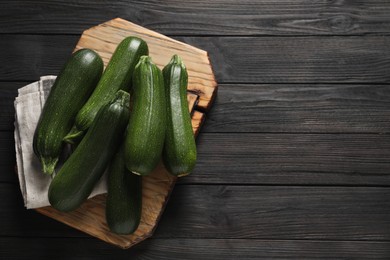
[106,146,142,235]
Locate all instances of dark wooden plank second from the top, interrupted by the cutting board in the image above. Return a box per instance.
[0,35,390,84]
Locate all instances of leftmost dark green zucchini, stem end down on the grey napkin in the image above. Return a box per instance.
[33,49,103,174]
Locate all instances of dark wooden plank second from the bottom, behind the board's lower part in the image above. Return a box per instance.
[0,184,390,241]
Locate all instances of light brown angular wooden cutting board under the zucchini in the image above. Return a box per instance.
[36,18,217,248]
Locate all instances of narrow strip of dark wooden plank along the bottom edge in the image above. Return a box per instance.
[0,237,390,260]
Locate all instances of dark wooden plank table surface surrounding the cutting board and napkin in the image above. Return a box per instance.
[0,0,390,259]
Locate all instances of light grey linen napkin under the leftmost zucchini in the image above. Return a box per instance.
[14,76,107,209]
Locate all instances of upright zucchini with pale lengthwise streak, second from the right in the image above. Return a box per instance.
[125,56,166,175]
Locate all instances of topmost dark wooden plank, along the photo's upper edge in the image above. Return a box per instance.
[0,0,390,35]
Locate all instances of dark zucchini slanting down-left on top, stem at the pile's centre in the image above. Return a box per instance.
[49,91,130,212]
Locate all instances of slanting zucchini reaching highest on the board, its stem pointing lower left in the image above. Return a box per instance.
[64,37,149,144]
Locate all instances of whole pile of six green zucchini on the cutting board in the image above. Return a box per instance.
[33,37,196,234]
